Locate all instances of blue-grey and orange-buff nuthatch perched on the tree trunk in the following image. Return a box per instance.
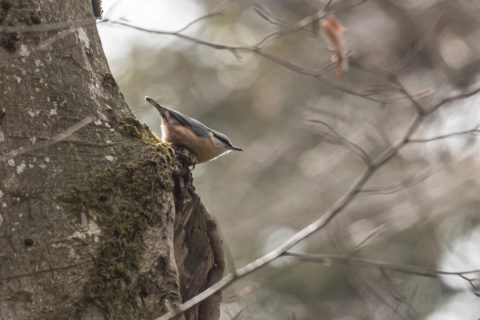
[145,97,243,163]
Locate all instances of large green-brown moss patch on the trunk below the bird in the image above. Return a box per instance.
[58,118,177,314]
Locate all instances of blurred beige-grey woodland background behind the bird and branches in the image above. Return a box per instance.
[98,0,480,320]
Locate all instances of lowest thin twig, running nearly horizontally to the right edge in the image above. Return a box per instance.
[283,251,480,279]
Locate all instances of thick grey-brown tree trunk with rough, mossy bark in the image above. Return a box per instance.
[0,0,224,319]
